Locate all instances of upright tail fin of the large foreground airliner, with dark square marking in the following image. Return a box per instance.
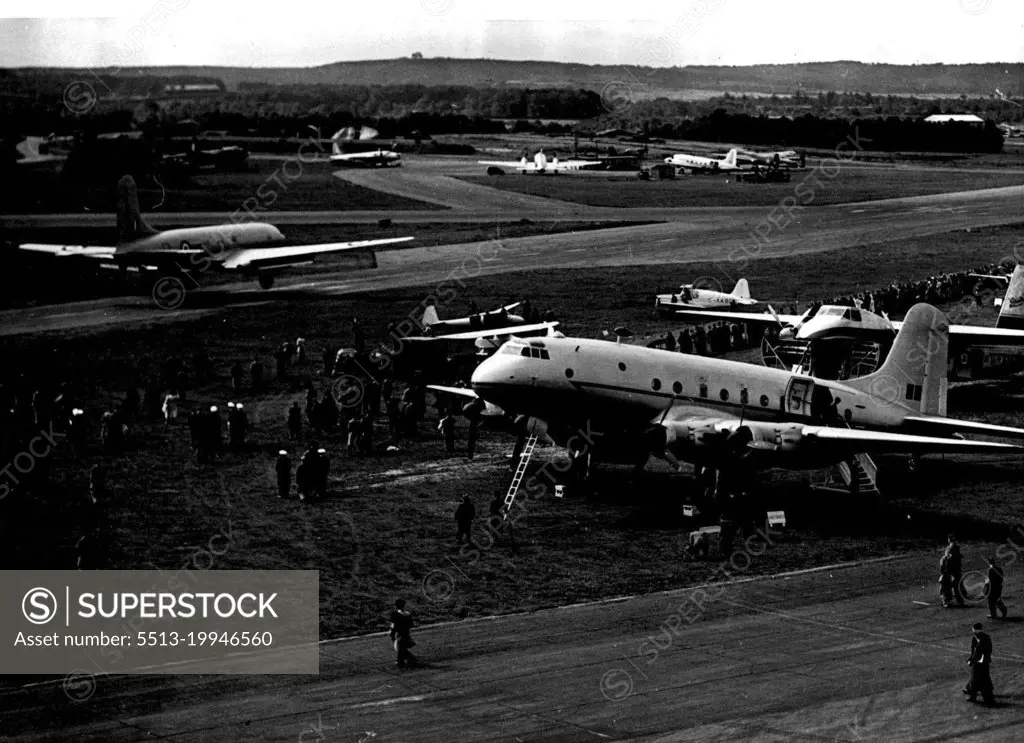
[844,304,949,416]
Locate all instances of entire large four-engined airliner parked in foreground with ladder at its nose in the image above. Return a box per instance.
[462,304,1024,489]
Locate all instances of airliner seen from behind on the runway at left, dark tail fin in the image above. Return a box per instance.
[20,175,414,289]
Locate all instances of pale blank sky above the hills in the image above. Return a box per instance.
[0,0,1024,68]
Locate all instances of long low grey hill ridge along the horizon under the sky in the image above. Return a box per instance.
[11,57,1024,97]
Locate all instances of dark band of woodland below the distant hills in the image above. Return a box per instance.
[0,73,1007,151]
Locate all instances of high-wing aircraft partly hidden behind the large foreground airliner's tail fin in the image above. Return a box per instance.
[674,265,1024,381]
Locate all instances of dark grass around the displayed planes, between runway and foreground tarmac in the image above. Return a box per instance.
[0,225,1024,638]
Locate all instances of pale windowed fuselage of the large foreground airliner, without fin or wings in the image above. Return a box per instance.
[472,338,912,440]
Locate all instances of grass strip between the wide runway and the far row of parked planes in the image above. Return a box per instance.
[460,165,1024,208]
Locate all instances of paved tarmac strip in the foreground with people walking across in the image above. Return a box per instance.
[0,548,1024,743]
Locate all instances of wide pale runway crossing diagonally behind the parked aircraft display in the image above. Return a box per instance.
[0,186,1024,336]
